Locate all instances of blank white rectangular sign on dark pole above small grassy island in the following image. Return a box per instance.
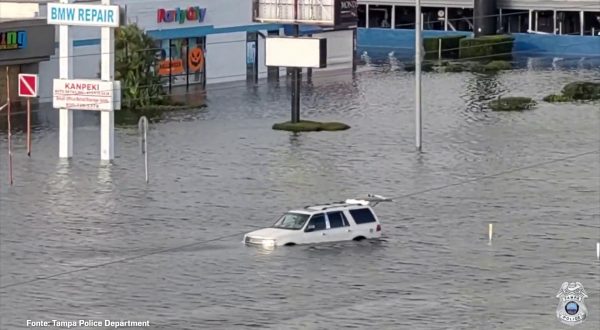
[265,37,327,68]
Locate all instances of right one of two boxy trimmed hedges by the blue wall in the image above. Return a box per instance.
[459,35,514,61]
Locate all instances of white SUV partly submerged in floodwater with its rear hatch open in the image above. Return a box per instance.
[244,194,391,247]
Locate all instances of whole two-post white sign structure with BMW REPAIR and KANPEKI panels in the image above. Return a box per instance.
[47,0,121,160]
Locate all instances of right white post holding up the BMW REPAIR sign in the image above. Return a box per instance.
[100,0,115,160]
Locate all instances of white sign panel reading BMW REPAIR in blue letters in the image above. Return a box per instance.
[48,2,120,27]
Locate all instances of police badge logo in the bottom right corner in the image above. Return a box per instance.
[556,282,587,325]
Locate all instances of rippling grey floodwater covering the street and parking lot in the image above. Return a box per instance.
[0,55,600,329]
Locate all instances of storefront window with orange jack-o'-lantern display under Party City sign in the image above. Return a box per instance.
[156,37,206,87]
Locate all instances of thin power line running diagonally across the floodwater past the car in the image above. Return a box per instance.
[0,150,599,289]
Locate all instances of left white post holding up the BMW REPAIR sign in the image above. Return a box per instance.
[58,0,73,158]
